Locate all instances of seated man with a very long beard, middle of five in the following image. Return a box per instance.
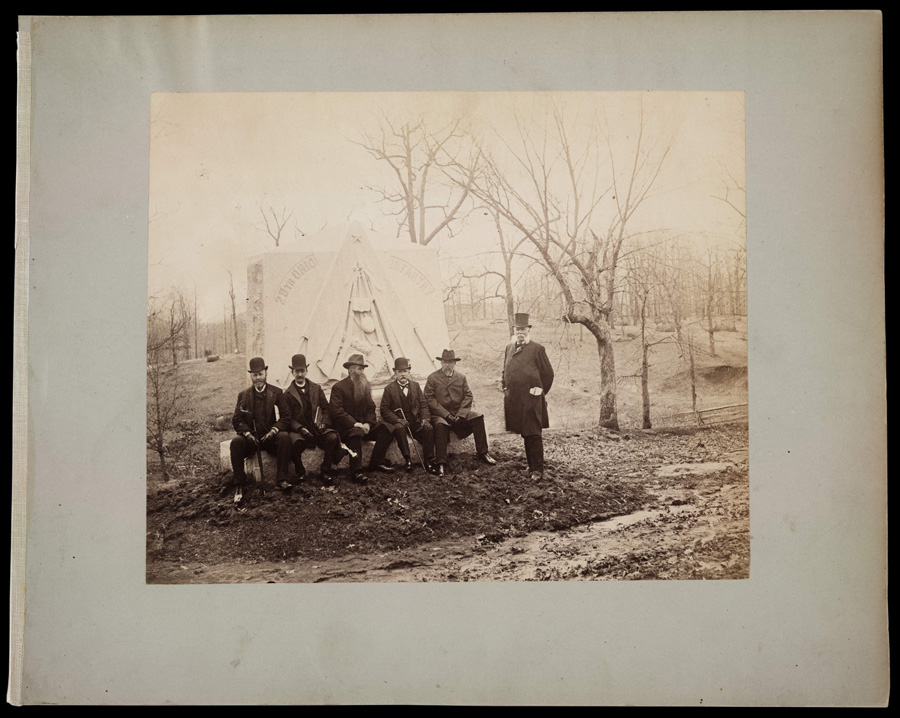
[331,354,393,483]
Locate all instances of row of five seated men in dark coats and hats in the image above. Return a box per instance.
[231,349,496,501]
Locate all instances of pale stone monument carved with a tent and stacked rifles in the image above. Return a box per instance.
[247,223,449,388]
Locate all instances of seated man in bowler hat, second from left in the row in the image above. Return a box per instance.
[281,354,344,489]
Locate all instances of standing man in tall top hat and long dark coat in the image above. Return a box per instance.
[501,314,553,479]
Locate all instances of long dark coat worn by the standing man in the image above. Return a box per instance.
[502,342,553,436]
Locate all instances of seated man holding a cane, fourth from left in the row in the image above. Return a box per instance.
[381,357,436,473]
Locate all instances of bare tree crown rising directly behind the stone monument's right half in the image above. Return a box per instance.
[354,115,479,245]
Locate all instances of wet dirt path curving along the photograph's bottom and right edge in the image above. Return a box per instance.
[147,458,750,583]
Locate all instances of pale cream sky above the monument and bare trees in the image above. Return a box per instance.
[149,92,745,319]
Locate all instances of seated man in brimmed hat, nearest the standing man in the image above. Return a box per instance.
[425,349,497,476]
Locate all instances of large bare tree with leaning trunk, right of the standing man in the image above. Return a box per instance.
[457,102,672,429]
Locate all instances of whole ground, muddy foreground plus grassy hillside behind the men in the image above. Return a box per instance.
[146,321,750,583]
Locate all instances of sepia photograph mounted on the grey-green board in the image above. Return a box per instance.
[146,92,751,584]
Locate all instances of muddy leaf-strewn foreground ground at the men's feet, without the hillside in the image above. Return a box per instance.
[147,426,750,583]
